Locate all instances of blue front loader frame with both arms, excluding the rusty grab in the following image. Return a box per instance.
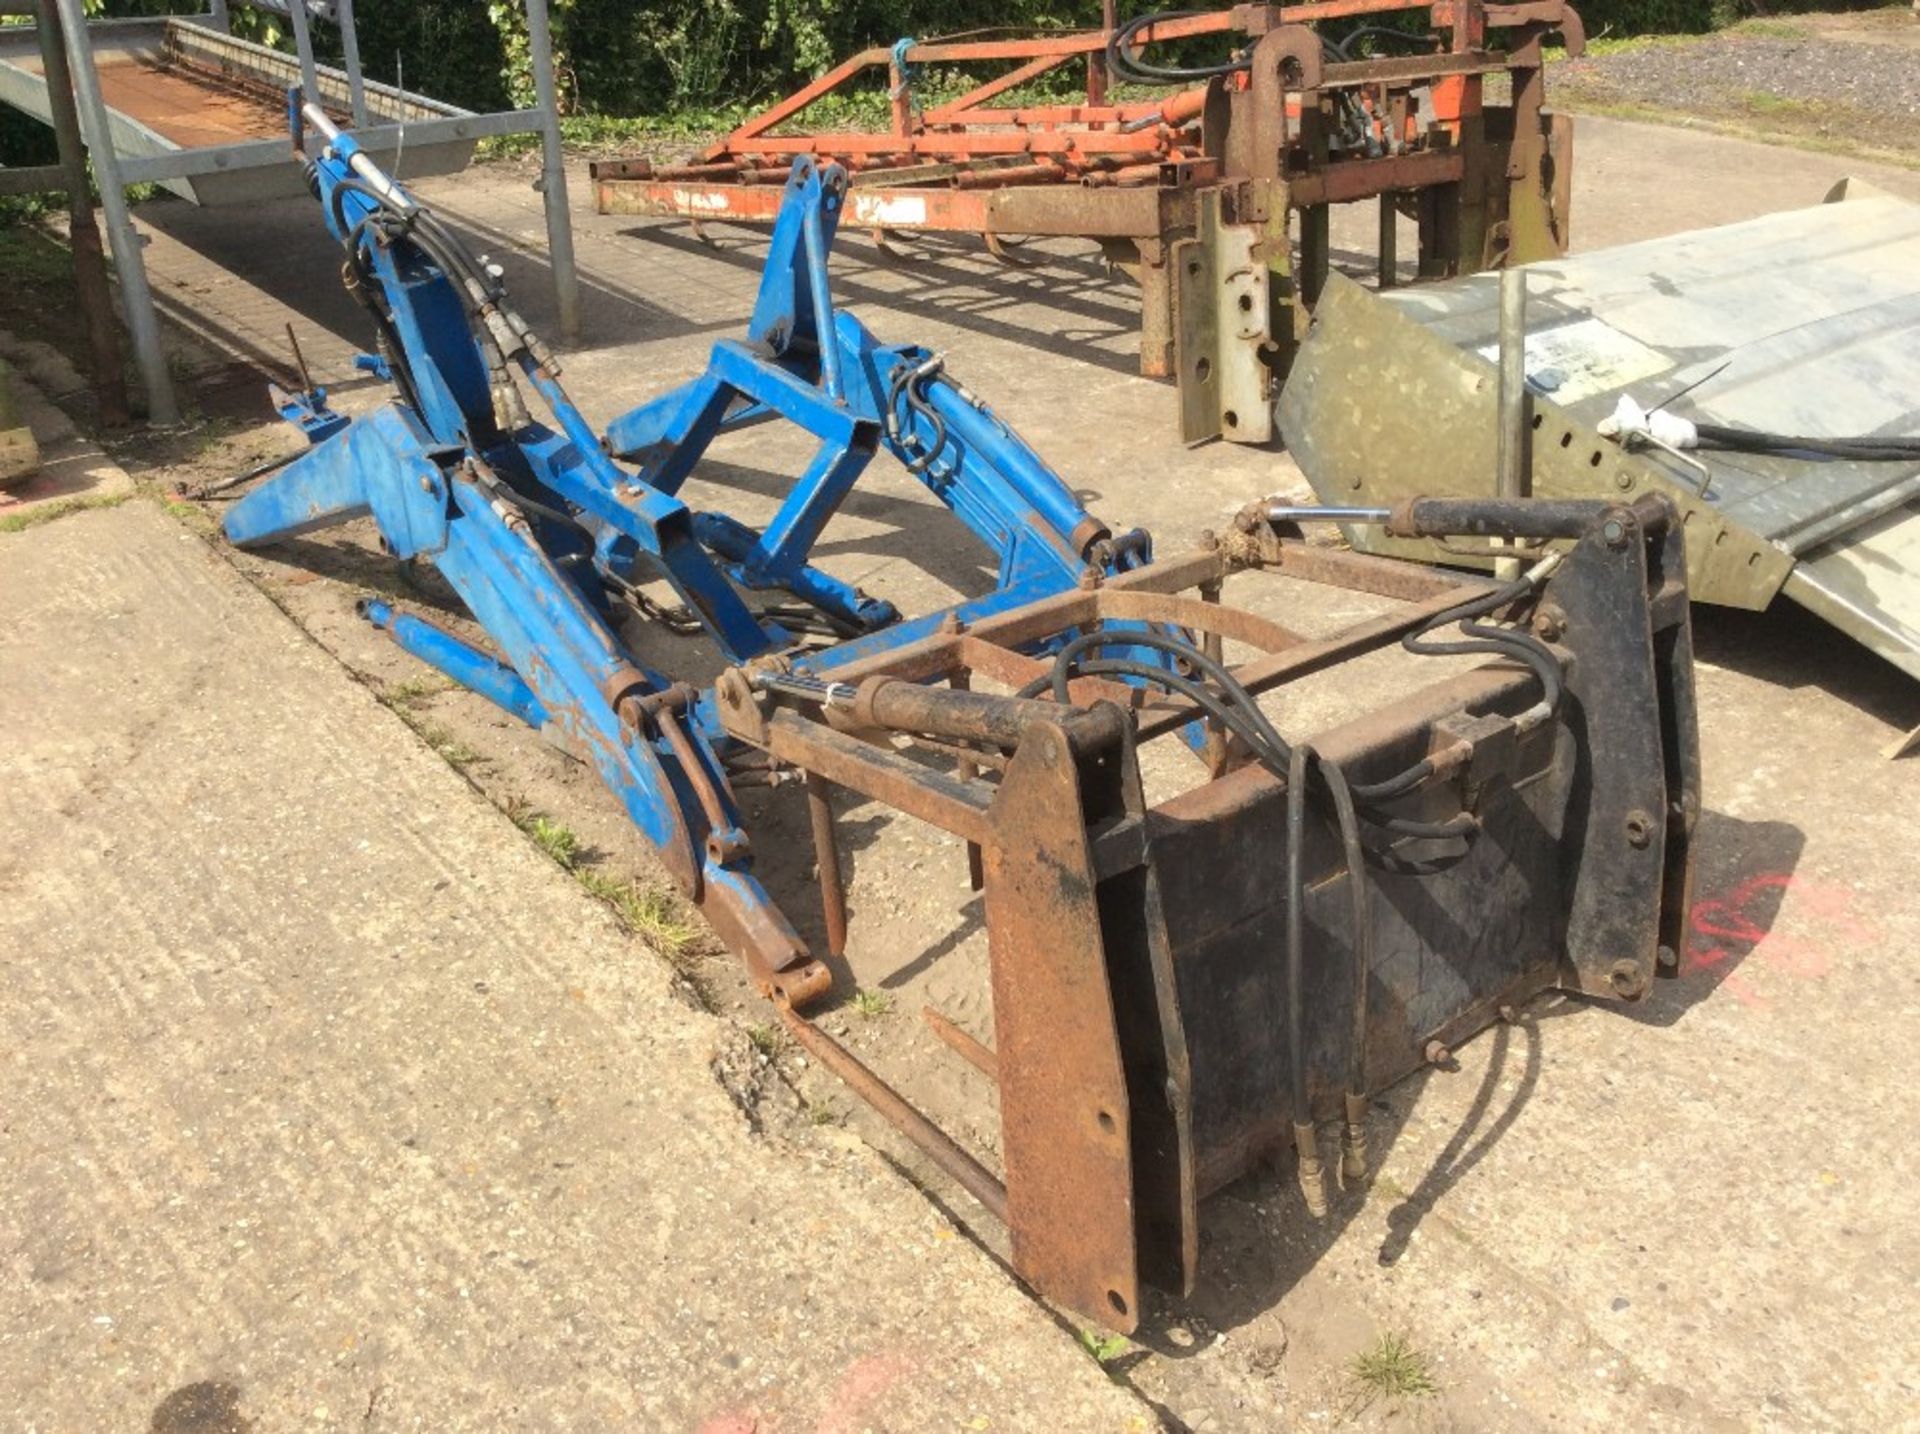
[225,90,1150,1004]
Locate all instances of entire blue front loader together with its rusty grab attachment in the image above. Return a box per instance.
[225,98,1699,1330]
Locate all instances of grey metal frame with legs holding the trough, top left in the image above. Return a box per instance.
[0,0,580,424]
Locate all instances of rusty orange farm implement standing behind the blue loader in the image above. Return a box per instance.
[593,0,1584,443]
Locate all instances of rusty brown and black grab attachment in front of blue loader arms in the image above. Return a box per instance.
[720,499,1699,1330]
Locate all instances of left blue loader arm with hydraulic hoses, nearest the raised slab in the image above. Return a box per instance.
[225,102,829,1002]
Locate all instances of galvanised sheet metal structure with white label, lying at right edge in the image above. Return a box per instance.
[1281,186,1920,676]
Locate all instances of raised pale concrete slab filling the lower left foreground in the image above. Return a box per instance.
[0,501,1148,1434]
